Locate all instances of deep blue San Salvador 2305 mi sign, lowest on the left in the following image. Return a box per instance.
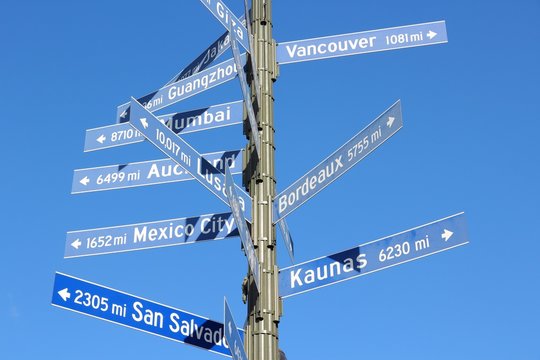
[51,272,243,356]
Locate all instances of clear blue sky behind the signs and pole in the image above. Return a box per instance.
[0,0,540,360]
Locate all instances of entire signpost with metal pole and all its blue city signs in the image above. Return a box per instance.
[57,0,469,360]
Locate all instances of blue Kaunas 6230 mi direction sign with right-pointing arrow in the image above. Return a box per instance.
[279,213,469,298]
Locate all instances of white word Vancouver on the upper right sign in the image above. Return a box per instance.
[285,36,377,58]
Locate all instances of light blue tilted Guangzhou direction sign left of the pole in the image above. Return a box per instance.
[117,54,245,123]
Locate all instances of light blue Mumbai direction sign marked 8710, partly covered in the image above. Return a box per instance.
[84,100,244,152]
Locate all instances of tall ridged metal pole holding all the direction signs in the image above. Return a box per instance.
[244,0,281,360]
